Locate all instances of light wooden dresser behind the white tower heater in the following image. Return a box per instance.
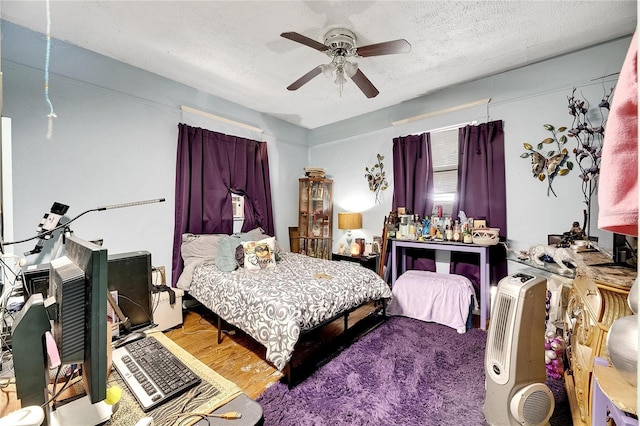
[564,253,636,425]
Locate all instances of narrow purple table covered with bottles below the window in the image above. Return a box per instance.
[389,239,491,330]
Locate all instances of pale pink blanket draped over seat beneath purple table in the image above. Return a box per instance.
[387,271,478,333]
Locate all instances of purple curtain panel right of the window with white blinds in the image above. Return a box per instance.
[450,120,507,288]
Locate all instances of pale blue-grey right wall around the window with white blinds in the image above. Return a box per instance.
[310,38,630,260]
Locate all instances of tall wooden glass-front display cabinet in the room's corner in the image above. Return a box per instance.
[298,178,333,259]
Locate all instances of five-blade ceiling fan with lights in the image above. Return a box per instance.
[280,28,411,98]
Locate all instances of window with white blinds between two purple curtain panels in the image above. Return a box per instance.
[431,129,458,216]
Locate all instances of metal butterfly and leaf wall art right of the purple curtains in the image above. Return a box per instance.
[520,124,573,197]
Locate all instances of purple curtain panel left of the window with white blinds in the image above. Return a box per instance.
[388,133,436,271]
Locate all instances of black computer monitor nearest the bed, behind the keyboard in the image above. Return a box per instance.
[108,251,153,330]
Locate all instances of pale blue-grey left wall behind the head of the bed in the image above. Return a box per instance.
[1,21,308,276]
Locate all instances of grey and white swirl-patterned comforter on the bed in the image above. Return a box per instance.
[189,253,391,370]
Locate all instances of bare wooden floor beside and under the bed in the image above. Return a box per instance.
[164,304,382,399]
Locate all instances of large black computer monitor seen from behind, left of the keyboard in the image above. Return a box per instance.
[49,236,108,403]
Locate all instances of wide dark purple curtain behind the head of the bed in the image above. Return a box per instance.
[172,123,275,284]
